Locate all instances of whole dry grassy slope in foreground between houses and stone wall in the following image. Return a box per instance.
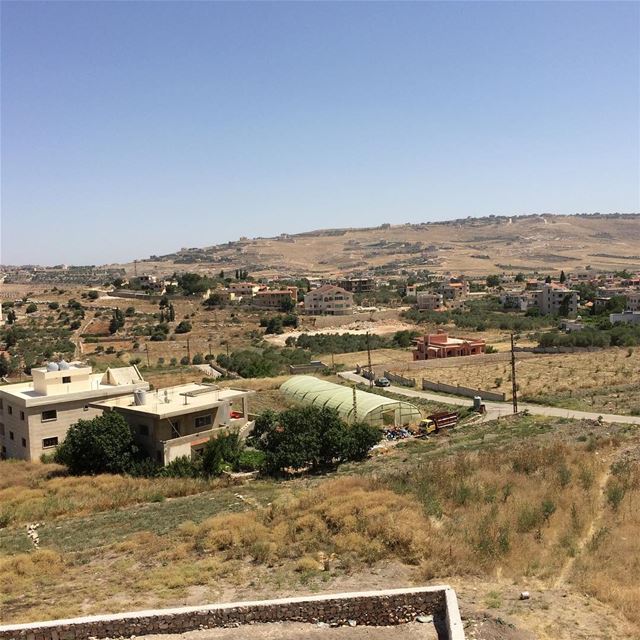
[0,416,640,638]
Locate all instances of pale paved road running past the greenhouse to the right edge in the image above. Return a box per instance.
[338,371,640,425]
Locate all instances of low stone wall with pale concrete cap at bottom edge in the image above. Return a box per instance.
[0,586,464,640]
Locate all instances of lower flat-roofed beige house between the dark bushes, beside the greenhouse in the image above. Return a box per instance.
[93,383,254,464]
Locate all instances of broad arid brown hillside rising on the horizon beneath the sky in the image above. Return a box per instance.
[115,214,640,276]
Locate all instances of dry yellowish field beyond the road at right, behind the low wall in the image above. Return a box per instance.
[390,348,640,415]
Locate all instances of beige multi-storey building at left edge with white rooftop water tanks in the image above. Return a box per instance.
[0,360,149,460]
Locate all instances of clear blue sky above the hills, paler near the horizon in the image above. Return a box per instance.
[0,1,640,264]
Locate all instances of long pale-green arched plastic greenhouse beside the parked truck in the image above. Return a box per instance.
[280,376,422,427]
